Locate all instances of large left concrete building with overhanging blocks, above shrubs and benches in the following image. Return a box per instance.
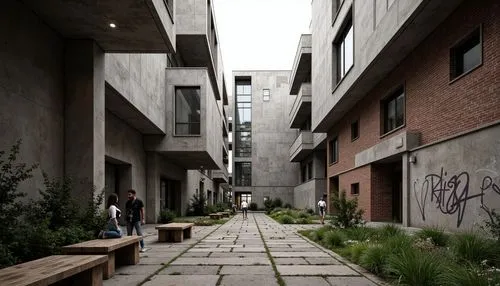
[0,0,228,223]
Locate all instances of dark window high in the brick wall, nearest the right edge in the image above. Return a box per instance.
[450,25,484,84]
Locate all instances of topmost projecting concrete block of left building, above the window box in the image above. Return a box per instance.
[175,0,222,101]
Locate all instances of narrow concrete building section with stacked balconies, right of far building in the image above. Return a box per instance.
[289,34,326,209]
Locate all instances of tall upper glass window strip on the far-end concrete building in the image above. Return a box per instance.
[234,80,252,157]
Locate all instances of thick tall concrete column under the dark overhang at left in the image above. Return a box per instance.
[64,40,105,201]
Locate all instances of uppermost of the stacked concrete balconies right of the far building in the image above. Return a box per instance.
[290,34,312,94]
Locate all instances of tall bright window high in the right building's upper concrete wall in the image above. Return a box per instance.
[334,11,354,83]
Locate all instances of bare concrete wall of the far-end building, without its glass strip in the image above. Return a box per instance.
[231,71,299,208]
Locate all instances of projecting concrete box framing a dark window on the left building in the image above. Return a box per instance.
[144,68,224,170]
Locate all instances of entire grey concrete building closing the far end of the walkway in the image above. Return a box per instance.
[231,71,299,208]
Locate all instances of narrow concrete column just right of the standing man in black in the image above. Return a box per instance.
[146,152,160,223]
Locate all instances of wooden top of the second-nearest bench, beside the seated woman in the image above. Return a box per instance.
[62,236,141,254]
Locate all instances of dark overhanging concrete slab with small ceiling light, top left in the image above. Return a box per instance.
[23,0,176,53]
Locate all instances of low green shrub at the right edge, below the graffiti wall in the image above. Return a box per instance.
[452,233,500,265]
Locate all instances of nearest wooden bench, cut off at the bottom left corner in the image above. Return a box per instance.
[0,255,108,286]
